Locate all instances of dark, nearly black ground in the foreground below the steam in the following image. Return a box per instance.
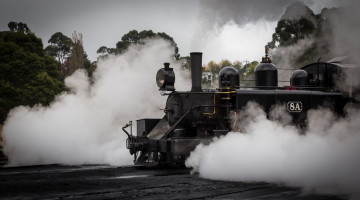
[0,165,348,200]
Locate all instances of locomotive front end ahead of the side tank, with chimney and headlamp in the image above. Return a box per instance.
[124,52,239,166]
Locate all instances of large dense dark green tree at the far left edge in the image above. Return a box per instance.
[0,23,65,124]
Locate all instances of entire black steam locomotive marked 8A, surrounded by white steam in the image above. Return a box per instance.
[123,52,351,166]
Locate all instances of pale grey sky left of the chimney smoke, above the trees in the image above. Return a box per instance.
[0,0,198,60]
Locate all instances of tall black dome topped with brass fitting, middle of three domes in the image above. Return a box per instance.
[255,47,278,89]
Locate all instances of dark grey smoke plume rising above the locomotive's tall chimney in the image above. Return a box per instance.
[193,0,292,48]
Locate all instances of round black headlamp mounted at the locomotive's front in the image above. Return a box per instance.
[156,63,175,91]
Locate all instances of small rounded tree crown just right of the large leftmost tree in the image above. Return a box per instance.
[45,32,71,65]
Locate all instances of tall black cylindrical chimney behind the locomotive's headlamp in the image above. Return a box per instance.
[190,52,202,92]
